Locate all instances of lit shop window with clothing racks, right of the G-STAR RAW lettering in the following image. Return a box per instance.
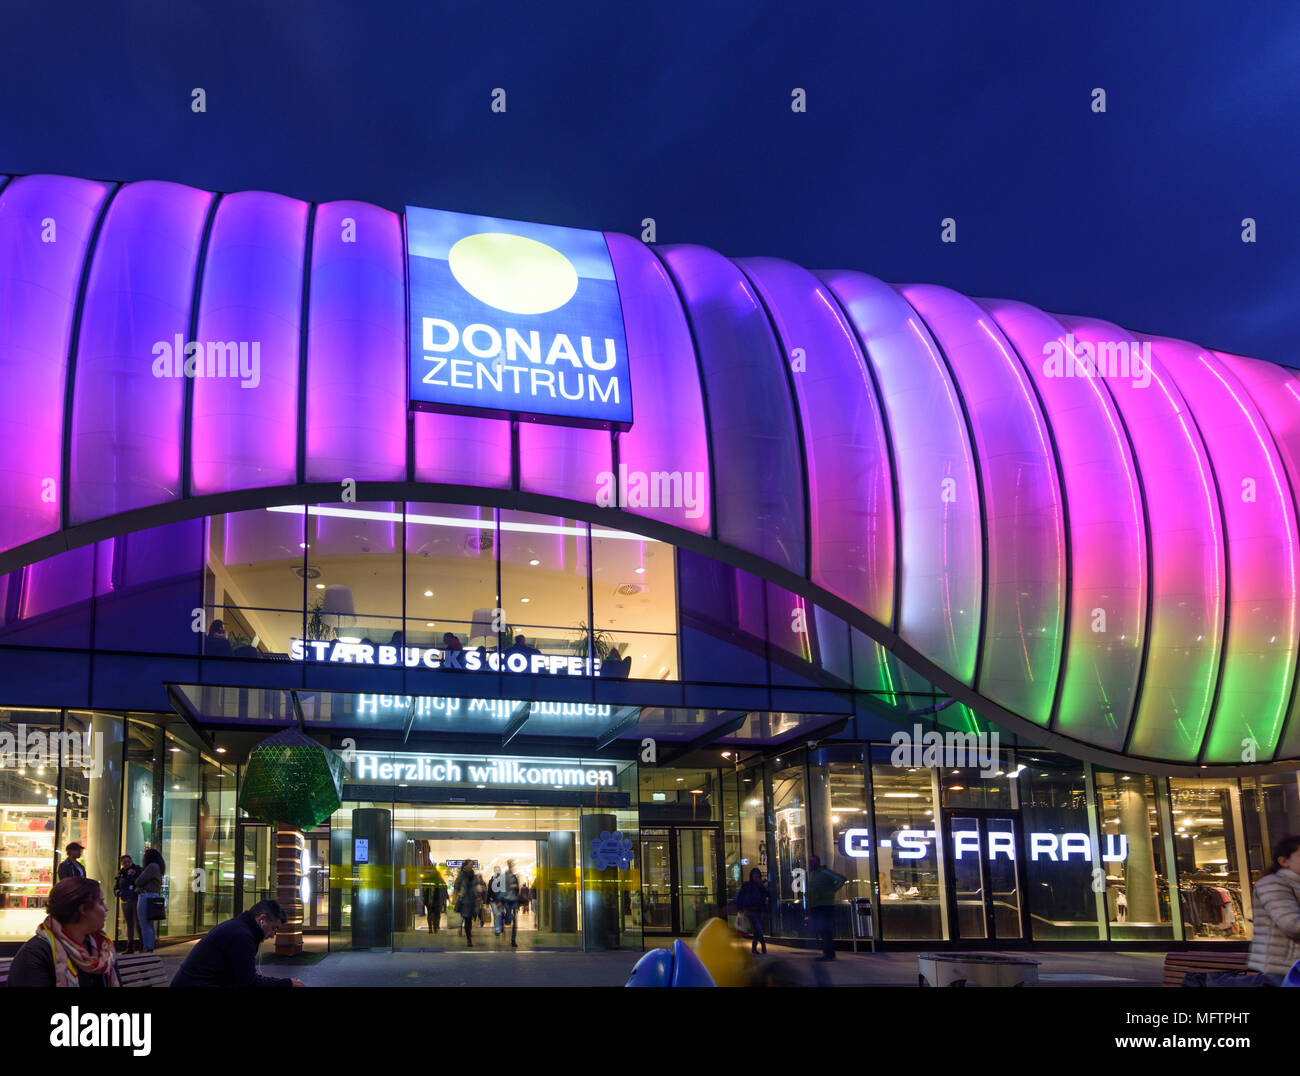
[1169,777,1249,941]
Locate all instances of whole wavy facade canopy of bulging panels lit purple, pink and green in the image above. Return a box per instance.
[0,175,1300,765]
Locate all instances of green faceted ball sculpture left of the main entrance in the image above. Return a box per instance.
[239,729,345,832]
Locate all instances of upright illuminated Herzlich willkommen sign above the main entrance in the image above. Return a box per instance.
[348,751,618,789]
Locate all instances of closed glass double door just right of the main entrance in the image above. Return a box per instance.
[641,825,727,937]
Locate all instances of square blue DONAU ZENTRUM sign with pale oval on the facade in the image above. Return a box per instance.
[406,205,632,429]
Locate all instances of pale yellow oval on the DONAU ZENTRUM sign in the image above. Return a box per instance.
[447,231,577,314]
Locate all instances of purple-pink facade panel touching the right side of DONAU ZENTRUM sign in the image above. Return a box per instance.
[605,231,711,534]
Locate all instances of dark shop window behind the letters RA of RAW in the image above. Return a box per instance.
[1015,752,1102,941]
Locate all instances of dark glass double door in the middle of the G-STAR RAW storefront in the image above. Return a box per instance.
[945,810,1027,942]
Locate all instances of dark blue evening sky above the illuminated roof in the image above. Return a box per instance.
[0,0,1300,365]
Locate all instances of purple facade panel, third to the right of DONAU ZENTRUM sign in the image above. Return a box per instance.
[737,257,894,624]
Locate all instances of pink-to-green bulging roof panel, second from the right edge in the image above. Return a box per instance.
[1144,338,1297,763]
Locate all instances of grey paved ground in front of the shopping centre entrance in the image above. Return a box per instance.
[159,942,1164,988]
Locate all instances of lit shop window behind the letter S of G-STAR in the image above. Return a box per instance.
[871,747,945,941]
